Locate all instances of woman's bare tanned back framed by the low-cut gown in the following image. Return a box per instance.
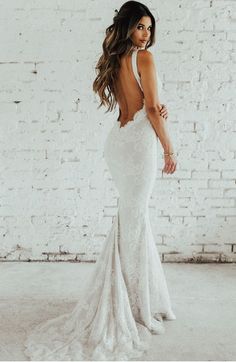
[116,50,144,127]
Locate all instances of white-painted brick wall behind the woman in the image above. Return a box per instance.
[0,0,236,262]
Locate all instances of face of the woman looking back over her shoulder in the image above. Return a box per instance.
[130,16,152,48]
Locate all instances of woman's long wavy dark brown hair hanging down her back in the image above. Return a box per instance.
[93,1,156,113]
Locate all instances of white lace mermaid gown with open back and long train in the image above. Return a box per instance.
[25,49,176,361]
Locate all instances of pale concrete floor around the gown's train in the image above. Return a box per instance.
[0,262,236,361]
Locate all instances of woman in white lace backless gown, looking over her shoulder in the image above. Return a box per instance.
[25,1,176,360]
